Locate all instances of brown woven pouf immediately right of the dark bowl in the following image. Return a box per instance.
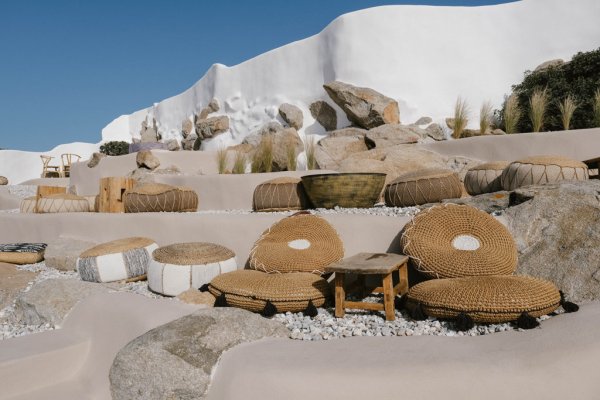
[384,169,463,207]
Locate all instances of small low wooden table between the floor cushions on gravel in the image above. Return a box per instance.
[325,253,408,321]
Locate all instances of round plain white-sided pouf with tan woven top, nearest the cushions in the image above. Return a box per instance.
[148,242,237,296]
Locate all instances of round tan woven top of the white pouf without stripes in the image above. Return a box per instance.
[152,242,235,265]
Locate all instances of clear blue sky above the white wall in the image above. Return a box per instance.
[0,0,509,151]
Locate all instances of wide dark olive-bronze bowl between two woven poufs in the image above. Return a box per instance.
[302,173,386,208]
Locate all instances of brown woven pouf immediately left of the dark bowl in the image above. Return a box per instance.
[252,177,308,211]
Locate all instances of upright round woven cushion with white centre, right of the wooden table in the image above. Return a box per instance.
[401,204,517,278]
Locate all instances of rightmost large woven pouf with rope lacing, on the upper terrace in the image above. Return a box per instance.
[501,156,589,190]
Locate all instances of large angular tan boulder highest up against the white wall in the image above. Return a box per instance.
[323,81,400,129]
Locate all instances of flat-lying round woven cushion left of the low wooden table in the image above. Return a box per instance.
[208,270,329,312]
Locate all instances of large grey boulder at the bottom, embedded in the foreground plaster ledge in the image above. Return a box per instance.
[109,308,289,400]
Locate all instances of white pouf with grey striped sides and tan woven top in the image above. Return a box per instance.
[77,237,158,282]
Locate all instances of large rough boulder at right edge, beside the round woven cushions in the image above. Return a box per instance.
[505,180,600,302]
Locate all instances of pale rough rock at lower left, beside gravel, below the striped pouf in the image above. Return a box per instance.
[15,279,109,327]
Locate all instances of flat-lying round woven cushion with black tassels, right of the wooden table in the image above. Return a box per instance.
[407,276,561,323]
